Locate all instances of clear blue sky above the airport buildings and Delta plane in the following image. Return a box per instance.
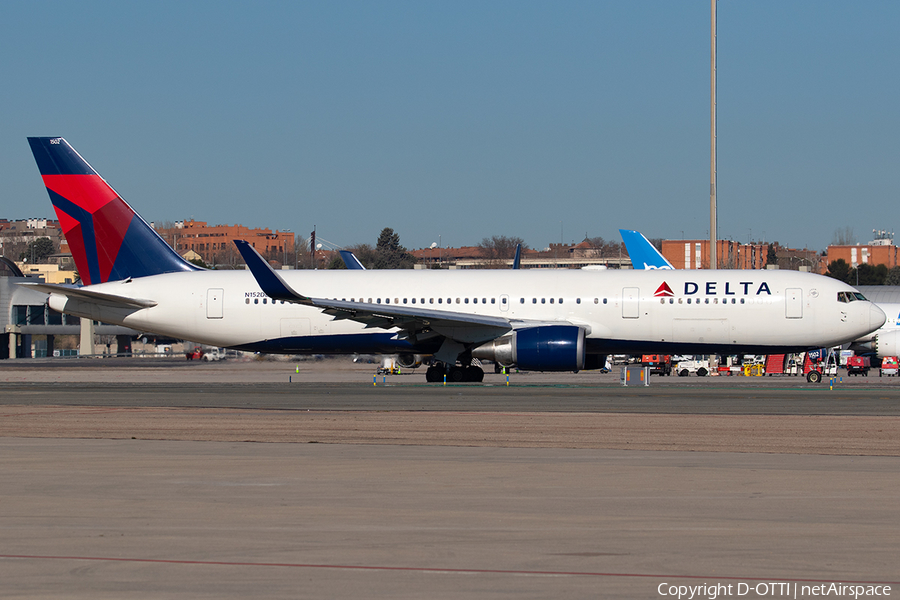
[0,0,900,249]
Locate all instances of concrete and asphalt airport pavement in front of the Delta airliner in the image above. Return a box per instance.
[0,361,900,598]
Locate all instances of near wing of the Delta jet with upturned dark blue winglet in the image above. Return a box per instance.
[234,240,522,343]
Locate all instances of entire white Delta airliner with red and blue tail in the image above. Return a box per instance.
[22,137,885,381]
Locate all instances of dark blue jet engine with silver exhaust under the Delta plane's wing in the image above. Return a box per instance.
[472,325,584,371]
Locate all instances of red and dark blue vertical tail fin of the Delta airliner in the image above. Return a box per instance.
[28,137,197,285]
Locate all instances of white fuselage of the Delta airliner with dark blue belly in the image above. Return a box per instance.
[50,270,884,353]
